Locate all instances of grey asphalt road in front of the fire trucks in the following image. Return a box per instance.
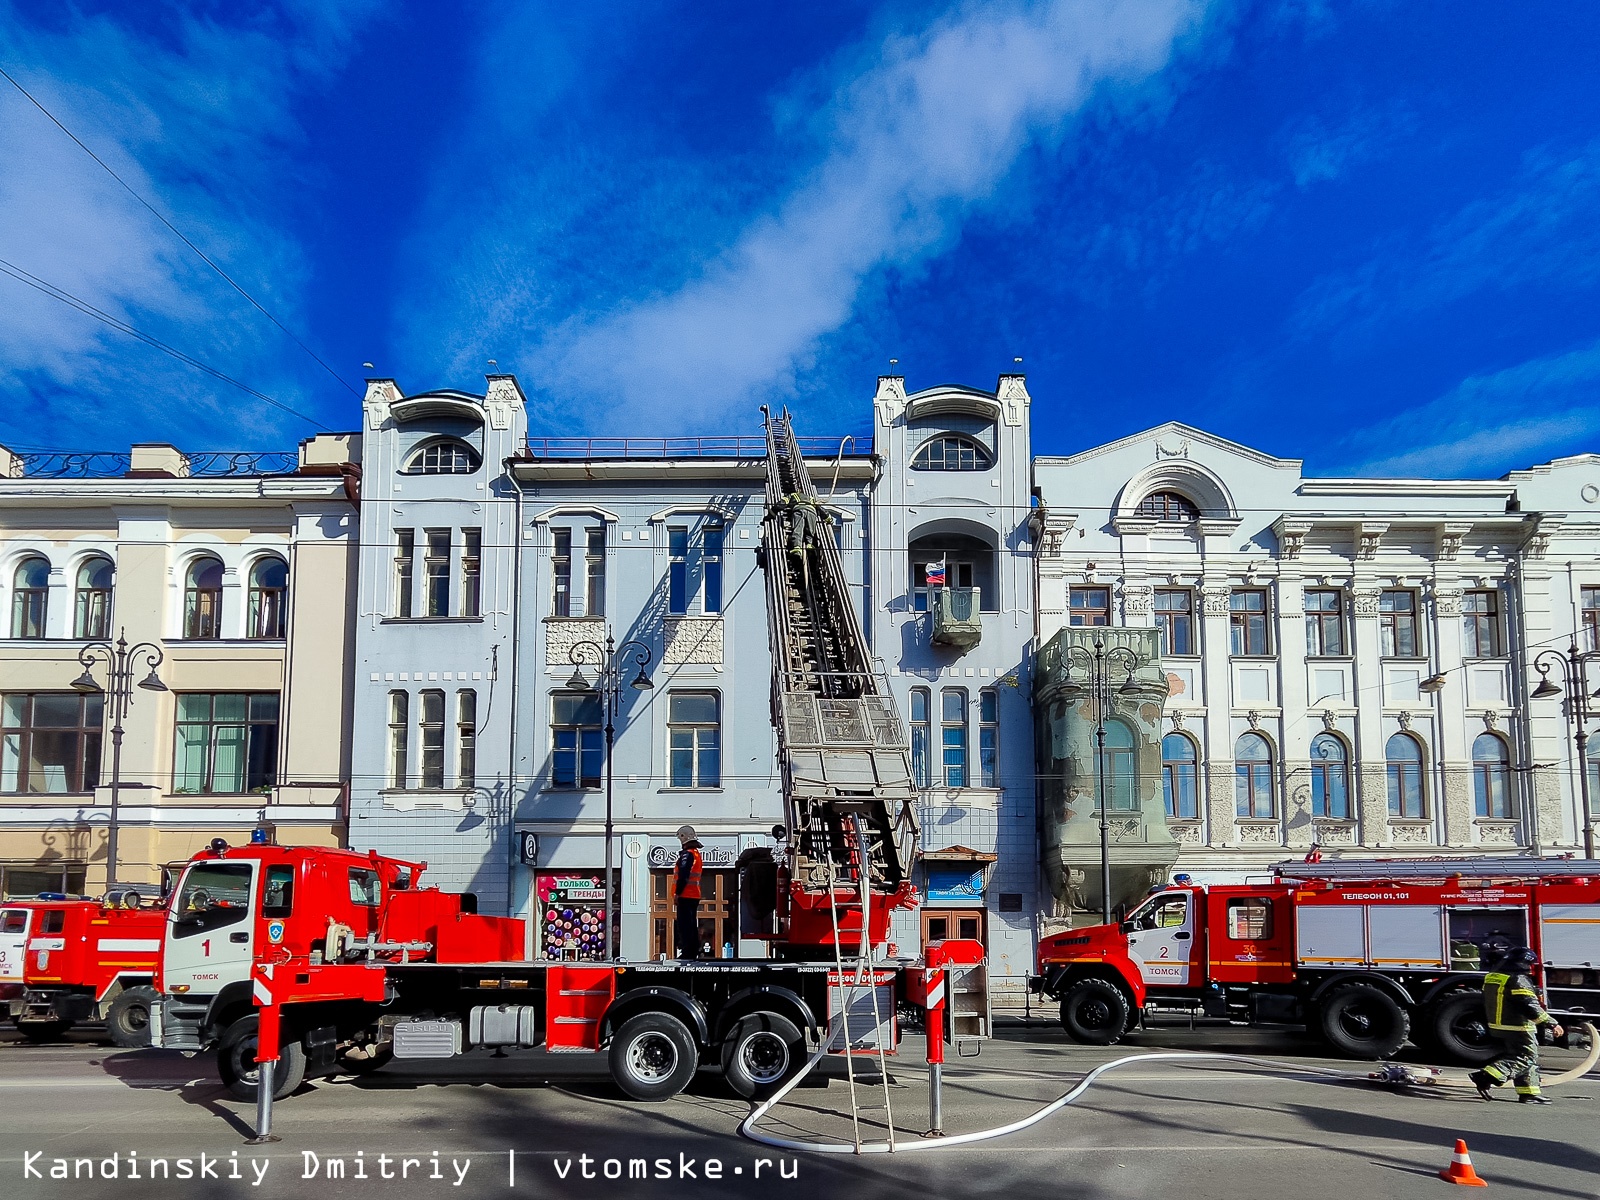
[0,1021,1600,1200]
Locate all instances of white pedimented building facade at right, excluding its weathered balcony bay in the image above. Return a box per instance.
[1034,422,1600,906]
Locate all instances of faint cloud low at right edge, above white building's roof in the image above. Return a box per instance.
[1342,342,1600,477]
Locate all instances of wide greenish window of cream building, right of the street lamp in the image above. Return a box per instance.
[173,691,278,795]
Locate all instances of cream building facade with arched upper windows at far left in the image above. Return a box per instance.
[0,435,360,898]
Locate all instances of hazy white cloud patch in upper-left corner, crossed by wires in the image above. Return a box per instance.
[0,0,371,446]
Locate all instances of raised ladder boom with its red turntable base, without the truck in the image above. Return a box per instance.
[762,408,918,957]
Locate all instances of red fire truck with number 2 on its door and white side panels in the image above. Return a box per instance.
[1030,858,1600,1064]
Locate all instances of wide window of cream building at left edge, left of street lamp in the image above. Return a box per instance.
[0,691,106,792]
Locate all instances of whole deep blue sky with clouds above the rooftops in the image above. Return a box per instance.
[0,0,1600,475]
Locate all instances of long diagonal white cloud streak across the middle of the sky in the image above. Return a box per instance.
[403,0,1206,429]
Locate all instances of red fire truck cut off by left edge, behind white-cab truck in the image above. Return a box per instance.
[0,891,165,1046]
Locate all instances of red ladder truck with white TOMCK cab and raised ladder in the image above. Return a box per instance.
[152,414,987,1144]
